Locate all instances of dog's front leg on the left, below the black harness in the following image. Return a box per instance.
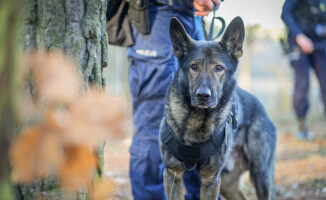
[163,168,183,200]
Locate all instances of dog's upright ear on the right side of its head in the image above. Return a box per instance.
[220,17,245,60]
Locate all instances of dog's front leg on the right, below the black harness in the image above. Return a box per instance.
[200,177,221,200]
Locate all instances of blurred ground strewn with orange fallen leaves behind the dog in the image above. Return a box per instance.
[105,115,326,200]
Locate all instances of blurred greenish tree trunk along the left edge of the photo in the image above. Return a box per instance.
[0,0,21,200]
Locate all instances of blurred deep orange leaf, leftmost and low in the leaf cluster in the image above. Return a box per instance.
[9,126,61,183]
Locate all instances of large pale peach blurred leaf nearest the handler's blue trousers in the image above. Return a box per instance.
[59,90,127,146]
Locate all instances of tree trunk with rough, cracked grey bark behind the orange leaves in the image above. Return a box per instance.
[20,0,108,199]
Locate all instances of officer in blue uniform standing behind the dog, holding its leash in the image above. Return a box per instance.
[127,0,220,200]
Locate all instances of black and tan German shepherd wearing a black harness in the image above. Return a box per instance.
[159,17,277,200]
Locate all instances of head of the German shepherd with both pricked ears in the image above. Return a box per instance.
[170,17,245,108]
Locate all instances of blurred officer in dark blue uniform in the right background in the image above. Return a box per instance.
[281,0,326,140]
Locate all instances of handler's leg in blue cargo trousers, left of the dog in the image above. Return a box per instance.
[127,5,177,200]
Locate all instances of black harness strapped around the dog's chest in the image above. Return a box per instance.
[161,103,237,171]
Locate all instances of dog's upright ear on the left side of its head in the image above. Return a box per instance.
[170,17,194,58]
